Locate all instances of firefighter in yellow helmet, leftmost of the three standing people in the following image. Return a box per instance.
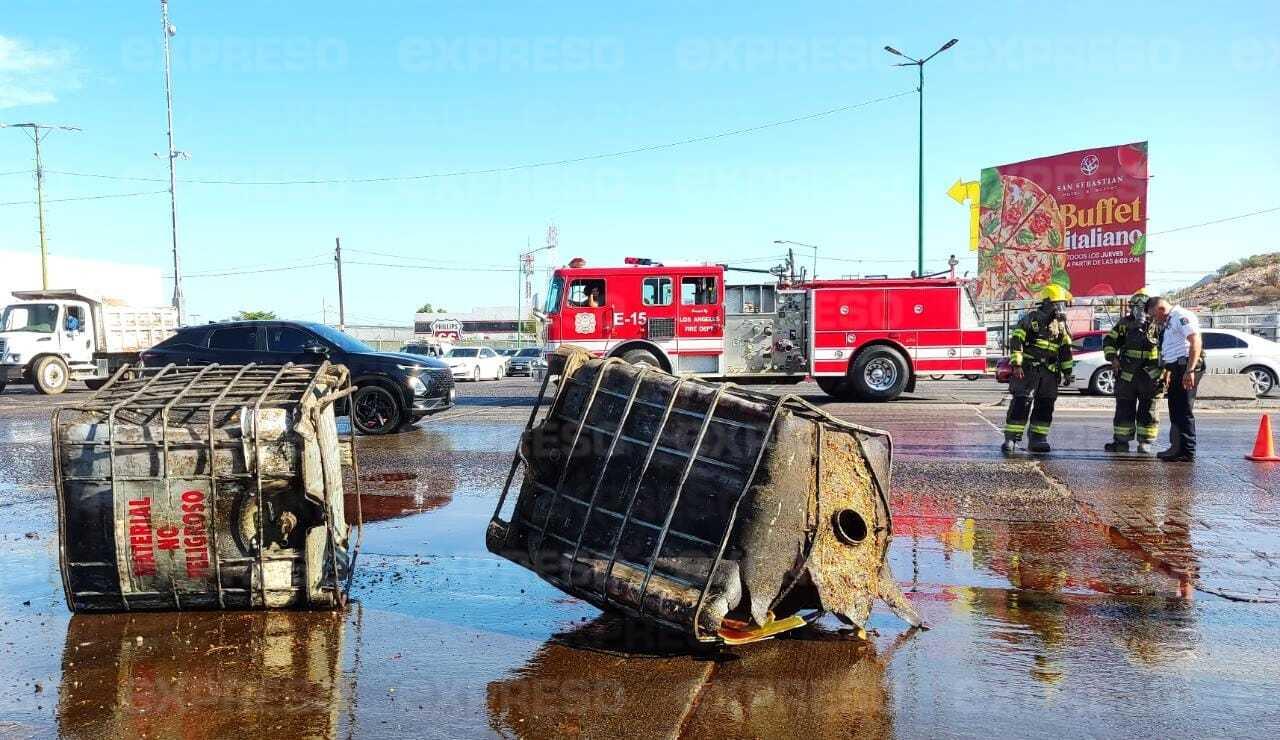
[1000,284,1073,453]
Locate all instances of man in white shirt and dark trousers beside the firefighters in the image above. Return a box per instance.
[1147,296,1204,462]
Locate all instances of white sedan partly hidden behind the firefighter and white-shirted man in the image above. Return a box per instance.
[1070,329,1280,396]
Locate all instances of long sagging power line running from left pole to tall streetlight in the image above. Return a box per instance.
[49,90,915,186]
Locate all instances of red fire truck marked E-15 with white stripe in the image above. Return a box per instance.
[540,257,987,401]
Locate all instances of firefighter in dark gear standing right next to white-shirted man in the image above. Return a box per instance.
[1102,289,1165,453]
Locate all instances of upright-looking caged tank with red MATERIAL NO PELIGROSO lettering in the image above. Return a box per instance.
[52,362,360,612]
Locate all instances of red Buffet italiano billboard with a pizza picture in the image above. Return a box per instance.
[978,142,1147,301]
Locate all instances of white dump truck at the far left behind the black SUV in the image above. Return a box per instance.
[0,289,178,394]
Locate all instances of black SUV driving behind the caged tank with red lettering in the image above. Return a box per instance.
[142,321,454,434]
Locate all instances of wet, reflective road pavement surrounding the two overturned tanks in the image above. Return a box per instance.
[0,380,1280,737]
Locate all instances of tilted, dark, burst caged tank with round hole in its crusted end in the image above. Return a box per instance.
[486,348,920,644]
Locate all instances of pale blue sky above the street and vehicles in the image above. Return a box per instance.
[0,0,1280,323]
